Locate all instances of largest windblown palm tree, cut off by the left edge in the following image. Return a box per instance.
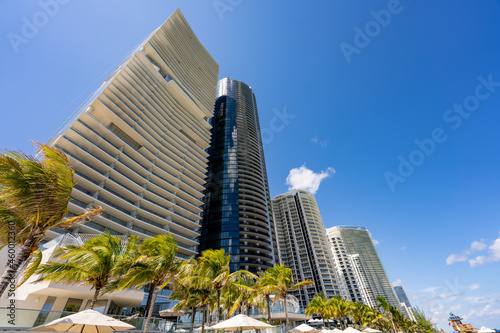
[0,143,101,296]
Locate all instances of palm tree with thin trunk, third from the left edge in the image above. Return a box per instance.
[118,234,180,333]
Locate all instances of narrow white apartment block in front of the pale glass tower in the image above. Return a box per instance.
[327,229,376,307]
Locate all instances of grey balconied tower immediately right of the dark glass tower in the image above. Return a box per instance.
[272,190,341,307]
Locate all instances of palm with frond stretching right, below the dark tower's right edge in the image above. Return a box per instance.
[264,264,314,332]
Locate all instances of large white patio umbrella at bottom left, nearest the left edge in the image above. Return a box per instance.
[28,310,135,333]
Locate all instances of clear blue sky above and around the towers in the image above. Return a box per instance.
[0,0,500,331]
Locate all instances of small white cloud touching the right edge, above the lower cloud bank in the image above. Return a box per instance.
[446,232,500,267]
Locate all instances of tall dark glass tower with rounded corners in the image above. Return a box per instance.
[199,78,278,272]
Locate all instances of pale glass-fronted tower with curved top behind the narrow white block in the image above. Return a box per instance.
[327,226,400,308]
